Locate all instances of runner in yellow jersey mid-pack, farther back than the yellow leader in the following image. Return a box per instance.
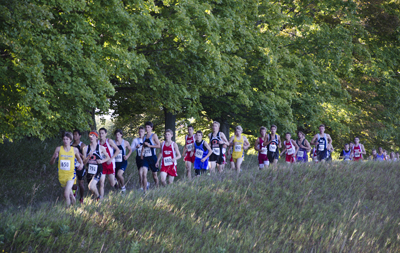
[229,126,250,172]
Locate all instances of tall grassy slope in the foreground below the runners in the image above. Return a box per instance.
[0,140,400,252]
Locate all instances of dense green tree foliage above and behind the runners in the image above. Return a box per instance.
[0,0,400,150]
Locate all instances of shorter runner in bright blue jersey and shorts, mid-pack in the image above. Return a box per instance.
[192,131,212,176]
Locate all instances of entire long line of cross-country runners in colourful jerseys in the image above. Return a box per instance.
[50,121,398,206]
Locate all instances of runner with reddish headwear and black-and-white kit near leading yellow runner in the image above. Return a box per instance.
[83,131,110,200]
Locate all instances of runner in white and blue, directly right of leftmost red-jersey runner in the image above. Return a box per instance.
[114,129,132,192]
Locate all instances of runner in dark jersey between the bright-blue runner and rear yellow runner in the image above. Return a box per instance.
[208,121,228,172]
